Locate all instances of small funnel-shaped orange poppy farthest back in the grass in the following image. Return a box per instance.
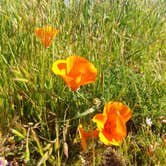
[35,26,58,48]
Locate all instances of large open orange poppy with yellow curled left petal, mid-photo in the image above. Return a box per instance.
[52,56,97,90]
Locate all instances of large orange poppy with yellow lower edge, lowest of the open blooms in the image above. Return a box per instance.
[93,102,132,146]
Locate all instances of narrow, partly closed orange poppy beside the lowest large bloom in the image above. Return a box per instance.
[78,124,99,151]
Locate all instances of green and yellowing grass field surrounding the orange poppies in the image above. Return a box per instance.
[0,0,166,165]
